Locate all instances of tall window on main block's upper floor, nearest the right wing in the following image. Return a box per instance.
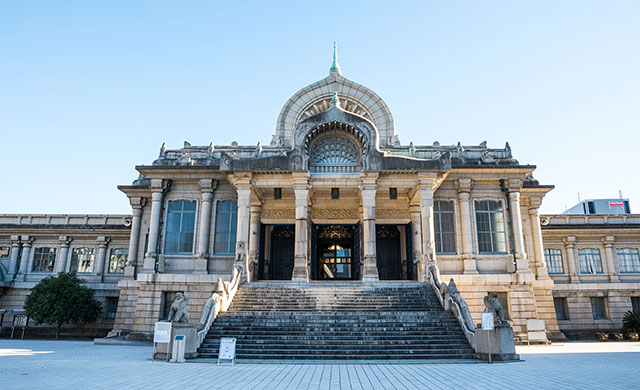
[476,200,507,253]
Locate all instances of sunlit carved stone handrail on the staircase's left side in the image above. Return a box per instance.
[197,264,244,348]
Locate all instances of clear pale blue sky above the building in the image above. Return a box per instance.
[0,1,640,213]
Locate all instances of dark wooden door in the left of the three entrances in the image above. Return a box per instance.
[269,225,295,280]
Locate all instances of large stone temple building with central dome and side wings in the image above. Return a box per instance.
[0,47,640,341]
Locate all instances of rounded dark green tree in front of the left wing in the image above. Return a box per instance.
[24,272,102,339]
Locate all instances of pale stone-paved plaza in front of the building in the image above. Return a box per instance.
[0,340,640,390]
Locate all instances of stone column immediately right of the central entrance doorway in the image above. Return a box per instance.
[356,173,379,282]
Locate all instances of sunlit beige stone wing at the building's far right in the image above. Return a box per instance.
[543,214,640,338]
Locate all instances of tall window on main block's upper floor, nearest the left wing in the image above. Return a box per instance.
[164,200,196,254]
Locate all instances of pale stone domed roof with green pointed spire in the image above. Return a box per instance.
[272,44,399,147]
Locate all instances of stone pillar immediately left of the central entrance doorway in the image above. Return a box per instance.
[291,173,309,282]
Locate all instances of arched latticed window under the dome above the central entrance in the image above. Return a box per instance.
[309,131,362,173]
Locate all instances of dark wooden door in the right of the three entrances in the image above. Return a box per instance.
[376,225,402,280]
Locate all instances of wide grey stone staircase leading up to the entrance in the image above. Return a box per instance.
[198,282,473,360]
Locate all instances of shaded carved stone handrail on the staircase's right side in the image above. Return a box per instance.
[427,263,476,350]
